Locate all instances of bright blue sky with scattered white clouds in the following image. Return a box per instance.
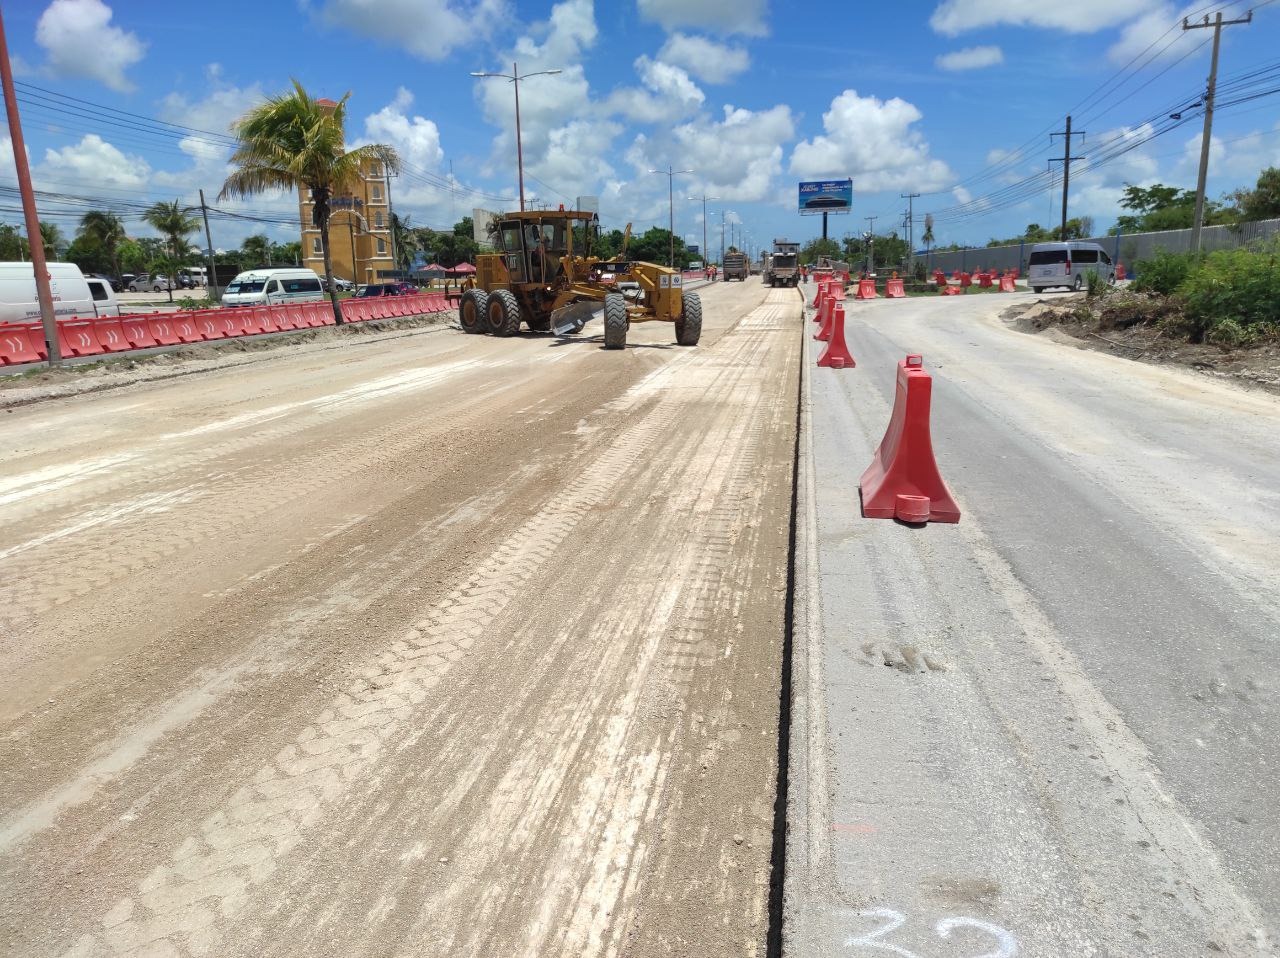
[0,0,1280,258]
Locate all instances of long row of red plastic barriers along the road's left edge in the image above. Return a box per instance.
[0,293,449,366]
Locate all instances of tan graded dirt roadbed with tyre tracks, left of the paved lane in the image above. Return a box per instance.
[0,283,800,958]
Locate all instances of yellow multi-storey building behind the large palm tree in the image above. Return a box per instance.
[298,100,396,284]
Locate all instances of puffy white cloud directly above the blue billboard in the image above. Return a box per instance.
[791,90,955,192]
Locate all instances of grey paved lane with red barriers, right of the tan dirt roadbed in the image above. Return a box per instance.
[785,296,1280,958]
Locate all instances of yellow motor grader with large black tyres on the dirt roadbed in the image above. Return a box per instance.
[458,209,703,350]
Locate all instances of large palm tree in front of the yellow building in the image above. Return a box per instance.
[218,81,401,324]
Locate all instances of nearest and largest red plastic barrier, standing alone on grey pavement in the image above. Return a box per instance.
[858,356,960,523]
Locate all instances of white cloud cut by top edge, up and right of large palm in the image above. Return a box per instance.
[302,0,512,60]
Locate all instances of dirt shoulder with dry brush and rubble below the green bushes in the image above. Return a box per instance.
[1000,291,1280,393]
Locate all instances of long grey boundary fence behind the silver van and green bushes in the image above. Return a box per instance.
[916,219,1280,274]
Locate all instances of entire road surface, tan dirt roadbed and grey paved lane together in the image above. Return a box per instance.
[0,279,1280,958]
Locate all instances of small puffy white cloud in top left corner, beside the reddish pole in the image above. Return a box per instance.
[36,0,147,93]
